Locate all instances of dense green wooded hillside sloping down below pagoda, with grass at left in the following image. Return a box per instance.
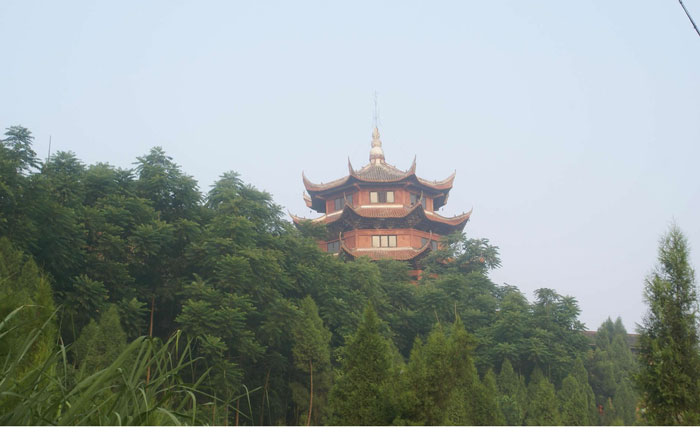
[0,126,660,425]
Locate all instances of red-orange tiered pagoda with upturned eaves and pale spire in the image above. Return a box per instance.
[290,127,471,275]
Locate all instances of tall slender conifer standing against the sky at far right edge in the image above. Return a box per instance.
[637,225,700,425]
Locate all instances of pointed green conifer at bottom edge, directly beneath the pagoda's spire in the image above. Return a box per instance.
[329,305,394,426]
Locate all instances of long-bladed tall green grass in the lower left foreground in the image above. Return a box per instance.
[0,306,252,426]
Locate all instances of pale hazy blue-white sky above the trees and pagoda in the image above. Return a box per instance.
[0,0,700,331]
